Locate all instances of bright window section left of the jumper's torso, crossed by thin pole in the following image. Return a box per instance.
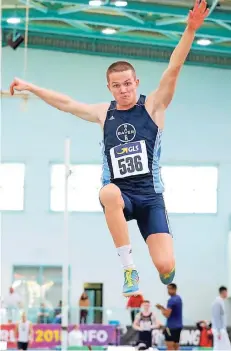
[51,165,102,212]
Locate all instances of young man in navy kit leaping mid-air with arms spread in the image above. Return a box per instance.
[10,0,209,296]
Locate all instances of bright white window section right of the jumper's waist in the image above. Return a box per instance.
[161,166,218,213]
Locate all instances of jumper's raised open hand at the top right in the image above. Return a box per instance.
[188,0,209,31]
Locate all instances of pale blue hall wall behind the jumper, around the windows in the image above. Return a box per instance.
[2,48,231,328]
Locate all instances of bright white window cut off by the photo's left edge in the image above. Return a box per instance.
[0,163,25,211]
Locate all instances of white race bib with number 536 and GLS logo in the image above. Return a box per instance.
[110,140,149,178]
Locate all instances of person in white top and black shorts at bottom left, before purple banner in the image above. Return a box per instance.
[15,313,33,350]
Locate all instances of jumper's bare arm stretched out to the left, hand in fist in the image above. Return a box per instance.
[10,78,106,123]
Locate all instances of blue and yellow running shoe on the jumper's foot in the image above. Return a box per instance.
[123,269,141,297]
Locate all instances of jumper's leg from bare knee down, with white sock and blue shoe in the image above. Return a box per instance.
[99,184,140,296]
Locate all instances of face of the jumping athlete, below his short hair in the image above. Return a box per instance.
[108,70,139,108]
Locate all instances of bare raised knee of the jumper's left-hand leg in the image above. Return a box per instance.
[99,184,124,208]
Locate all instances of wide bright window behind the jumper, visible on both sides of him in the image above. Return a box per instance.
[51,165,218,213]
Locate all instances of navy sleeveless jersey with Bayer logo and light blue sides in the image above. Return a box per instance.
[102,95,164,194]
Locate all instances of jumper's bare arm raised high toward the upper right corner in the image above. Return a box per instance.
[148,0,209,115]
